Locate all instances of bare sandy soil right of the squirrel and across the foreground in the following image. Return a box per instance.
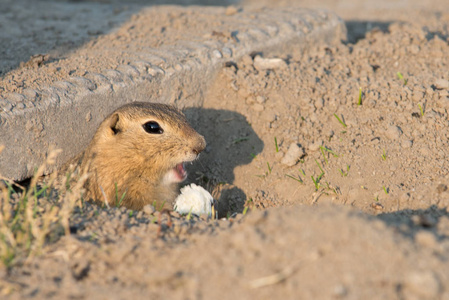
[0,0,449,299]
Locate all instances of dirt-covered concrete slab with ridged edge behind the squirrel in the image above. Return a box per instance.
[0,6,346,180]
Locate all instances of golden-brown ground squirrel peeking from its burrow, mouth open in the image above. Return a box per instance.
[81,102,206,209]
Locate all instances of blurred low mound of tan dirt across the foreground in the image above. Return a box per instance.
[3,206,449,299]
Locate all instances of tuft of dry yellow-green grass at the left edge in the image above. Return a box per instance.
[0,147,87,268]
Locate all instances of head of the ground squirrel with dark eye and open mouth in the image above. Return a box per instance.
[96,102,206,183]
